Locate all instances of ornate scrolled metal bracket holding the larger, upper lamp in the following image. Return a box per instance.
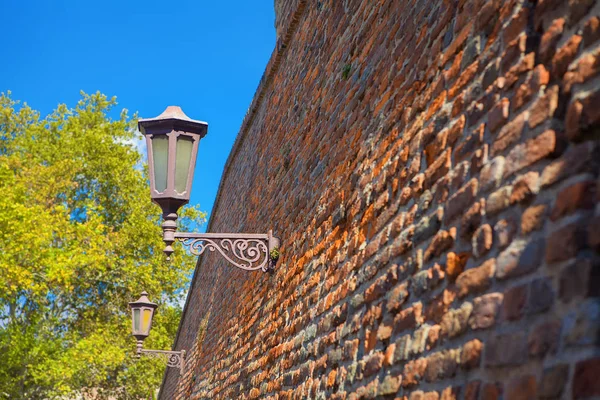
[175,231,279,272]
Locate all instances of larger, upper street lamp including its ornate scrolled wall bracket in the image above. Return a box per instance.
[138,106,279,272]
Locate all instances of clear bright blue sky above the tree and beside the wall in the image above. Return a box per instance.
[0,0,275,227]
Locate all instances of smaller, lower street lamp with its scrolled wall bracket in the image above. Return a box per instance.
[129,292,185,374]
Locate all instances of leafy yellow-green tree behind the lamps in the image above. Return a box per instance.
[0,92,205,399]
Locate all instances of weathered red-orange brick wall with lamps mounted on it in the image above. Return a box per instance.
[161,0,600,400]
